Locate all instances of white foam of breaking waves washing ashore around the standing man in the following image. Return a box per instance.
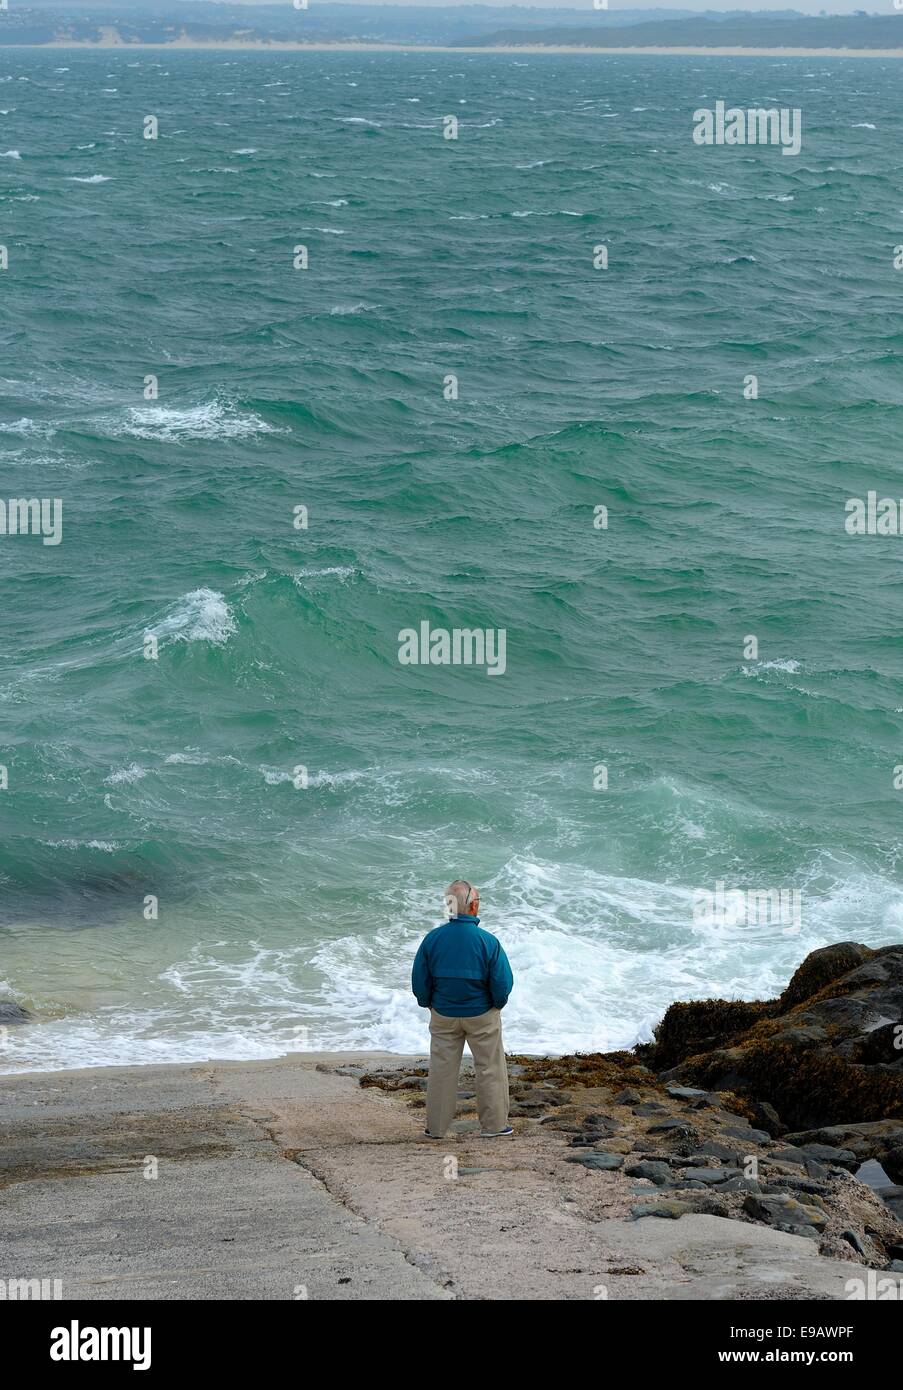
[0,856,903,1072]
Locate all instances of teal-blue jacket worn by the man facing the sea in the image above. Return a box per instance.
[411,913,514,1019]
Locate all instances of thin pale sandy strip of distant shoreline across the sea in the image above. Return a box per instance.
[12,39,903,58]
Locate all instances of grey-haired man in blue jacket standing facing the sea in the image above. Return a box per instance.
[411,878,514,1138]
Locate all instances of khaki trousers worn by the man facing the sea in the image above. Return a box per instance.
[426,1009,508,1138]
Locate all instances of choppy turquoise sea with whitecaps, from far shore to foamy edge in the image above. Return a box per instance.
[0,50,903,1070]
